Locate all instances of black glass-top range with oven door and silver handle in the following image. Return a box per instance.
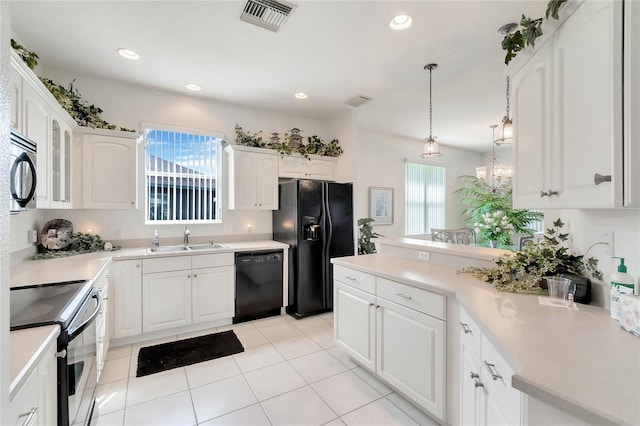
[10,281,102,426]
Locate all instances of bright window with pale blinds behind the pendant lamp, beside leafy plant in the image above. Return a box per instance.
[405,163,446,235]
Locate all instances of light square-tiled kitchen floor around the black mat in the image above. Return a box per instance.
[97,313,437,426]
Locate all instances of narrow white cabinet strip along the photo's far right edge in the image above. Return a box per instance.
[623,1,640,208]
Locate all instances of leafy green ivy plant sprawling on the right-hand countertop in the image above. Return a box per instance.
[462,219,602,293]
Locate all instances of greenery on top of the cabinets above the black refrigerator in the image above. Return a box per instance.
[235,123,344,159]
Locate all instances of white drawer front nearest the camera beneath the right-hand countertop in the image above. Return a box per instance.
[480,335,520,419]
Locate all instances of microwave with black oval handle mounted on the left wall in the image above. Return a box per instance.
[9,130,38,212]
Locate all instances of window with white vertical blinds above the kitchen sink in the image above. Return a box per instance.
[144,125,222,223]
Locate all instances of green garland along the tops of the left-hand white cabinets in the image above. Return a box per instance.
[11,39,135,132]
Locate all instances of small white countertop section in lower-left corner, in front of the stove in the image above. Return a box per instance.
[9,325,60,400]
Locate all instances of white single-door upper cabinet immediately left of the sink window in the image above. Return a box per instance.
[82,129,141,209]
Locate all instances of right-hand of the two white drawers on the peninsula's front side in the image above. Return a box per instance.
[376,277,446,320]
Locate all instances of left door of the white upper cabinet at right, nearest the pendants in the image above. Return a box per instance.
[512,40,556,208]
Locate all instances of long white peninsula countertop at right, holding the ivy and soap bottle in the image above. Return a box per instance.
[332,255,640,425]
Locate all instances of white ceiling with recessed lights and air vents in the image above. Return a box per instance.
[8,0,546,152]
